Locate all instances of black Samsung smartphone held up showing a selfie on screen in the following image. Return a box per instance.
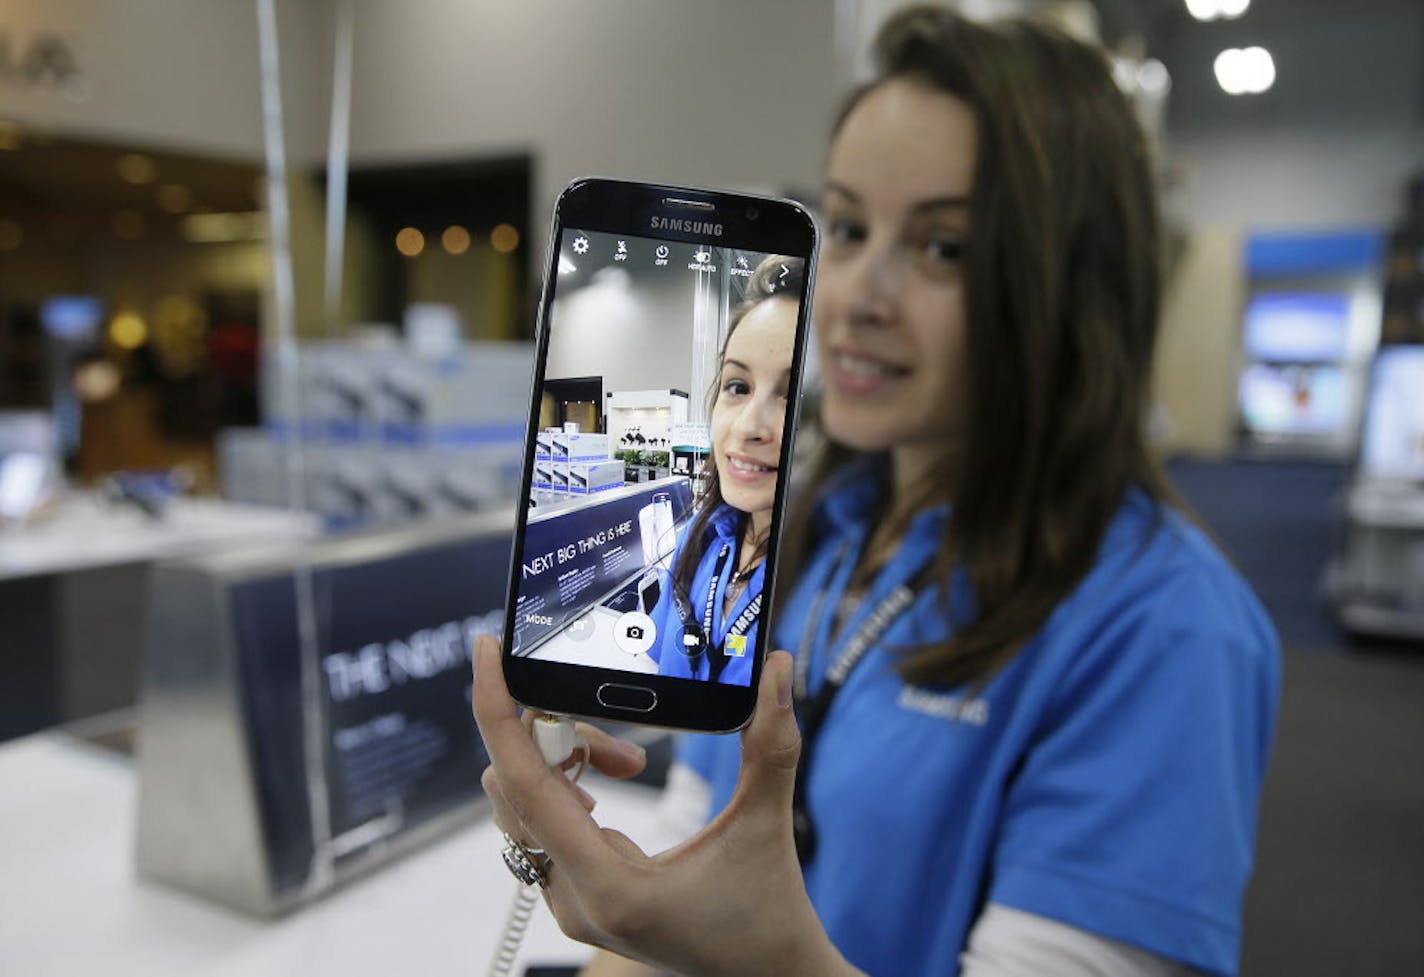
[504,179,817,732]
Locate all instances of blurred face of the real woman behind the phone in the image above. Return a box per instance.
[815,80,977,457]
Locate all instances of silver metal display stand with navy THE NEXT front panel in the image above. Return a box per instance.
[137,514,511,916]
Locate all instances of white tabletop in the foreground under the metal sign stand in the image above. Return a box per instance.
[0,732,664,977]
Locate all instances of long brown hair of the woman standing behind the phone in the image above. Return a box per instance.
[789,7,1169,685]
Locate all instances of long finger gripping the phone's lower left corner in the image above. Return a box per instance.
[471,635,608,873]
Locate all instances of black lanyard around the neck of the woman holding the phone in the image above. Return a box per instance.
[792,540,923,866]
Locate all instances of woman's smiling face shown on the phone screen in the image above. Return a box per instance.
[712,298,796,516]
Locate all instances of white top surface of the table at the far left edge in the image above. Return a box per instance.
[0,494,320,580]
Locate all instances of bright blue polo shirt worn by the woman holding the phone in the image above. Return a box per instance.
[681,480,1280,977]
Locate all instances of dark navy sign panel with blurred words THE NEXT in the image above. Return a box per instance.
[229,534,510,890]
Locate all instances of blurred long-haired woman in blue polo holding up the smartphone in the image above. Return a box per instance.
[474,9,1279,977]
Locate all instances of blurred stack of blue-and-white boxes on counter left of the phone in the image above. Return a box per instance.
[244,338,535,528]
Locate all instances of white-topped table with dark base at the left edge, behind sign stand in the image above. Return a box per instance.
[0,494,320,741]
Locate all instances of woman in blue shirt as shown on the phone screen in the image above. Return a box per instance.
[648,255,805,685]
